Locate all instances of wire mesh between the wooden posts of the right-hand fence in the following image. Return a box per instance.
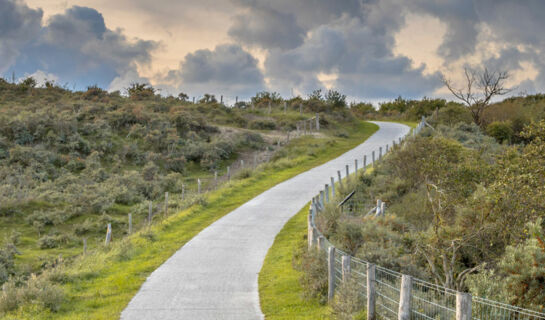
[311,120,545,320]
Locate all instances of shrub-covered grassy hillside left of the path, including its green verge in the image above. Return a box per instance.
[0,80,376,319]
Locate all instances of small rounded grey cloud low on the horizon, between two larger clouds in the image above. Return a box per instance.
[160,44,265,96]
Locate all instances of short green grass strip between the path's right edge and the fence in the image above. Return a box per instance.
[259,205,329,320]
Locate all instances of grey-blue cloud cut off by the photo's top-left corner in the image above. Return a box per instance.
[0,0,43,74]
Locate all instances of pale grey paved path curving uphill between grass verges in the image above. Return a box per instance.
[121,122,409,320]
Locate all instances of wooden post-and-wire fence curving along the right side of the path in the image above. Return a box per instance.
[308,118,545,320]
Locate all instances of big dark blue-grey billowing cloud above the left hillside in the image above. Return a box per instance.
[3,2,157,89]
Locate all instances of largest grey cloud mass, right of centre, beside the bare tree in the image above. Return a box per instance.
[265,1,441,98]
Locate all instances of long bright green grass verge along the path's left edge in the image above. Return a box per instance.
[5,122,378,319]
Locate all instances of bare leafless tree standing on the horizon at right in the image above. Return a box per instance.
[443,67,512,125]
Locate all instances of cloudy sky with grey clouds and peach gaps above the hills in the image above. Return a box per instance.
[0,0,545,101]
